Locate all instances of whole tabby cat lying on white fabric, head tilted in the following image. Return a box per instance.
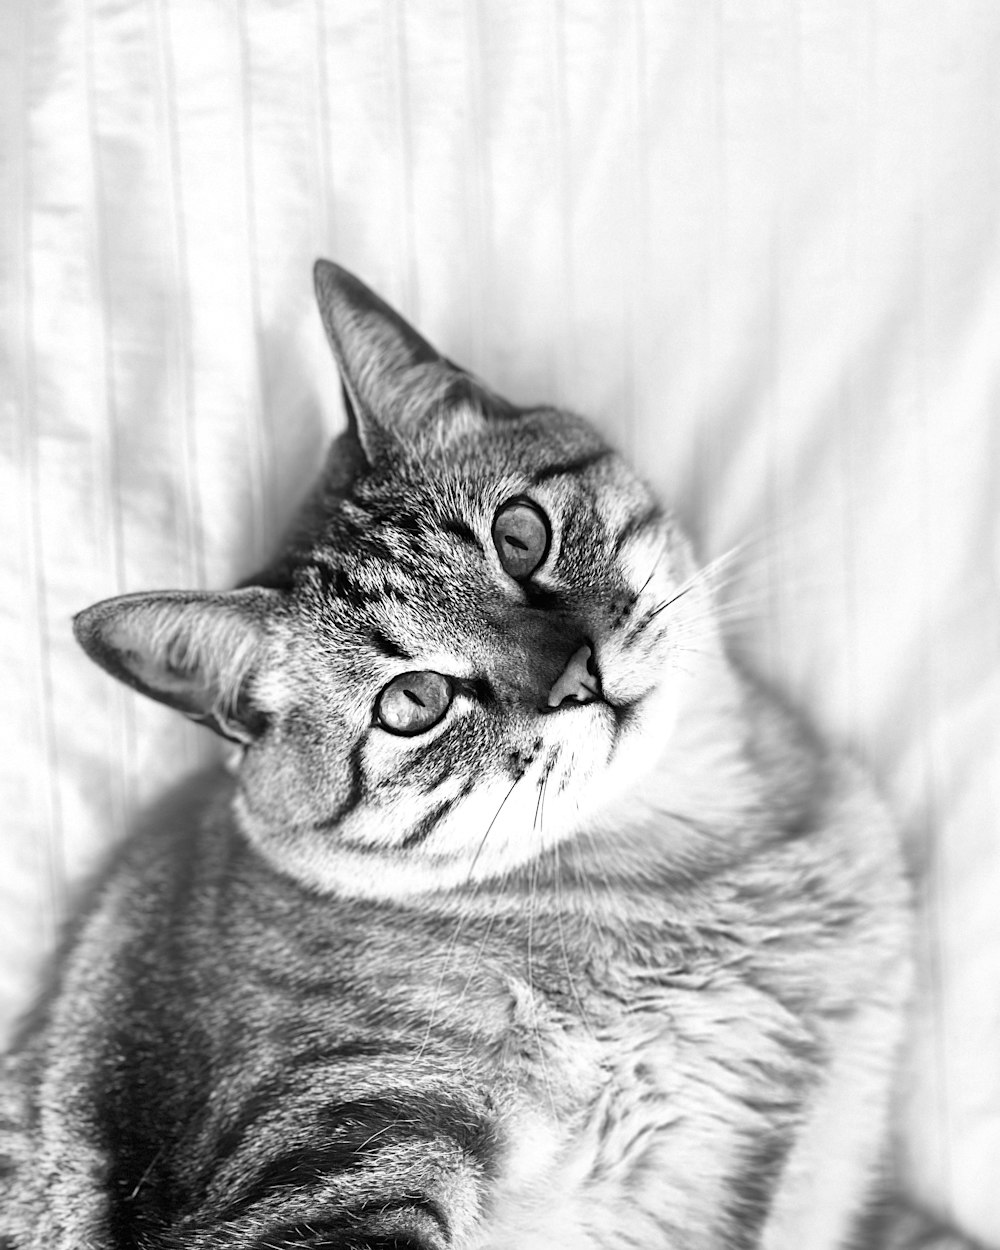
[0,261,970,1250]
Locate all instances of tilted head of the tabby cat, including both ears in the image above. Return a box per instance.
[75,261,715,894]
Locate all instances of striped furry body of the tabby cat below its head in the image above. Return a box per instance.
[0,750,905,1250]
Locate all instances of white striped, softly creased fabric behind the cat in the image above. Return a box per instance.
[0,0,1000,1241]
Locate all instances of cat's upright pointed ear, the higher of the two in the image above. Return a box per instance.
[313,260,516,462]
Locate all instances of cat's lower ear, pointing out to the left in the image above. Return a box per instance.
[73,588,281,744]
